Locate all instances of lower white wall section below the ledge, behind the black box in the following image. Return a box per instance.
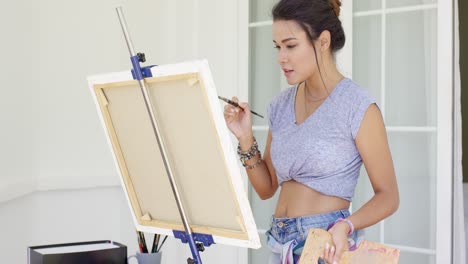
[0,187,243,263]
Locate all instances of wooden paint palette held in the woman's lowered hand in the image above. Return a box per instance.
[299,229,400,264]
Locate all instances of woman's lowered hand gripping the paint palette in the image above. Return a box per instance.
[322,222,349,264]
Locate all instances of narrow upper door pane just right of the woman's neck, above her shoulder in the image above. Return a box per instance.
[353,15,382,105]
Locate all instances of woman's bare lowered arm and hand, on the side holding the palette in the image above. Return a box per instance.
[323,104,400,263]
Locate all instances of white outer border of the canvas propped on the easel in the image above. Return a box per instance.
[88,60,260,248]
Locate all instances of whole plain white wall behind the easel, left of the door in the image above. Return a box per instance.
[0,0,245,263]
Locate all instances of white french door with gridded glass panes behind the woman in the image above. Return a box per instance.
[245,0,453,264]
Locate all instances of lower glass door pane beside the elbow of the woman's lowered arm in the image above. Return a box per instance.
[384,132,437,249]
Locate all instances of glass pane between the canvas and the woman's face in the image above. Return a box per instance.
[249,26,281,126]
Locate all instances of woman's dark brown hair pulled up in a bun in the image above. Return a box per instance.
[272,0,345,52]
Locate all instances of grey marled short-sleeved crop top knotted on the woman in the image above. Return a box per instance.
[268,78,375,201]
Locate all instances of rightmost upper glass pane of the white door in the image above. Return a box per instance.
[385,9,437,126]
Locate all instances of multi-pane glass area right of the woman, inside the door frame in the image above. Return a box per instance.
[353,0,444,264]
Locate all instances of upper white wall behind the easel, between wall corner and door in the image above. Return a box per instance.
[29,0,237,190]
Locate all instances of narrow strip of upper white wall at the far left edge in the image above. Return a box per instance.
[0,0,34,201]
